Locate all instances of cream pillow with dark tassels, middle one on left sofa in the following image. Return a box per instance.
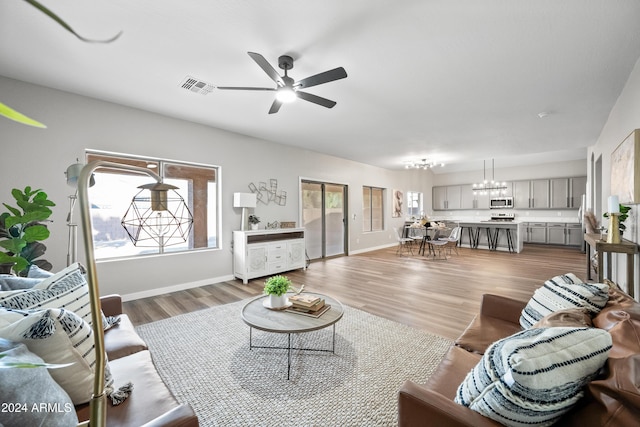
[0,308,113,405]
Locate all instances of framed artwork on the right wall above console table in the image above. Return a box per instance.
[611,129,640,204]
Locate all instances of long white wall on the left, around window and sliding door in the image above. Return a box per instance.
[0,77,432,297]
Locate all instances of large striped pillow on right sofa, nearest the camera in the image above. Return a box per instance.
[454,328,611,427]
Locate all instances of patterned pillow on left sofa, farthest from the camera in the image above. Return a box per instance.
[0,263,108,328]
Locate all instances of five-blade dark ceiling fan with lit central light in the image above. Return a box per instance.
[217,52,347,114]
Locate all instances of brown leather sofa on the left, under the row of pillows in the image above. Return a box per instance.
[76,295,198,427]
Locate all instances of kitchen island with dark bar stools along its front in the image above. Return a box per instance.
[457,220,525,253]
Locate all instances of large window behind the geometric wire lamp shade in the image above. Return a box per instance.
[87,153,219,259]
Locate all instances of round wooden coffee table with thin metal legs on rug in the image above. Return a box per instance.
[241,292,344,379]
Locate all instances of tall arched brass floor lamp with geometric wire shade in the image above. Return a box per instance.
[77,160,193,427]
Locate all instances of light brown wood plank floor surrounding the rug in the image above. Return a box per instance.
[124,245,586,339]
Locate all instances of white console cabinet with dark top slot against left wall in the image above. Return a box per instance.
[233,228,306,284]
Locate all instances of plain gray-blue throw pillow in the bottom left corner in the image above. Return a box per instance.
[0,338,78,427]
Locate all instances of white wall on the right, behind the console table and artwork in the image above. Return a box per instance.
[588,56,640,299]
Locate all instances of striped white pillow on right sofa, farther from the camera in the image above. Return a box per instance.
[520,273,609,329]
